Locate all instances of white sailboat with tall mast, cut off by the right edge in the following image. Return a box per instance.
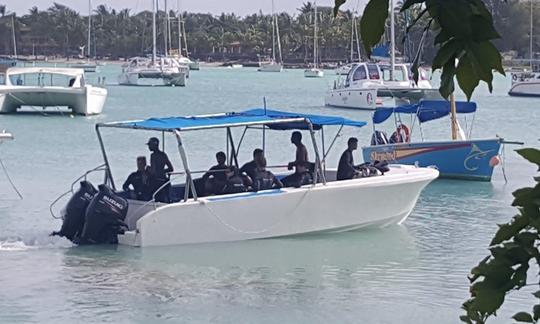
[508,0,540,97]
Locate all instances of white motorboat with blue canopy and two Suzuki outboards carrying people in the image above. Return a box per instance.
[51,109,439,247]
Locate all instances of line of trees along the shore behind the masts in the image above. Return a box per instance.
[0,0,540,62]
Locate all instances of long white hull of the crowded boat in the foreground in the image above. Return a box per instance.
[118,166,439,246]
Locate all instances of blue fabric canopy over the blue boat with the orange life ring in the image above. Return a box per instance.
[373,100,476,124]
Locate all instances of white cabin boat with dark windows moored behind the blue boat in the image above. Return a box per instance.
[325,63,441,110]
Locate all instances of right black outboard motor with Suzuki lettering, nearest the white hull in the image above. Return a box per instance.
[76,185,128,244]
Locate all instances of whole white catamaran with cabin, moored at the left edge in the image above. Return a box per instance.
[0,67,107,115]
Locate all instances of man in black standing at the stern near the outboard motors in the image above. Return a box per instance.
[146,137,174,202]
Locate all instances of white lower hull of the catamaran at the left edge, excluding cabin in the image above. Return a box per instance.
[0,85,107,115]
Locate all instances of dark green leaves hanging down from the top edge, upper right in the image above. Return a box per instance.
[334,0,504,99]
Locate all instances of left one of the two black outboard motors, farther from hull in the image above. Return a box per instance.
[51,180,97,241]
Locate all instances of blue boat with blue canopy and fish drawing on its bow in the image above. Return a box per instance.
[362,100,504,181]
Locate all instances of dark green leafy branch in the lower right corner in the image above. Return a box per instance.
[460,148,540,324]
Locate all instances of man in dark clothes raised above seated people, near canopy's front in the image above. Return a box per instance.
[281,131,312,188]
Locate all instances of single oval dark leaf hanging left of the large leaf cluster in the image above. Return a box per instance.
[360,0,389,57]
